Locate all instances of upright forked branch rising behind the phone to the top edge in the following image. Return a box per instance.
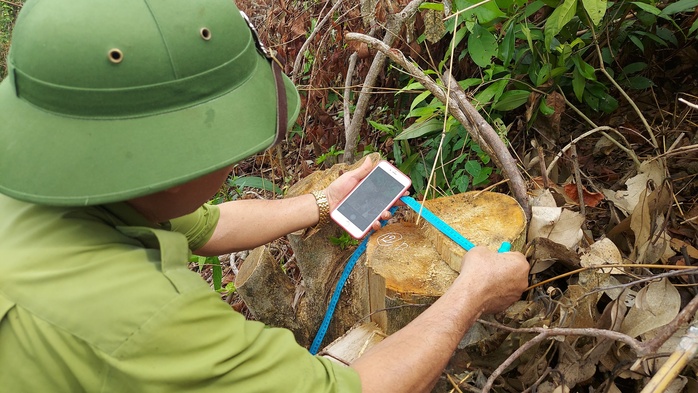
[343,0,424,163]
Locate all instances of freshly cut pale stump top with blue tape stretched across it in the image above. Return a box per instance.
[366,191,526,334]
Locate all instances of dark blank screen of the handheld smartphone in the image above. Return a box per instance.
[337,167,405,229]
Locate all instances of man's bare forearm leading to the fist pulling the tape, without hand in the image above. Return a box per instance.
[351,277,483,393]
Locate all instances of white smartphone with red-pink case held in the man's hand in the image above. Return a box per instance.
[330,161,412,239]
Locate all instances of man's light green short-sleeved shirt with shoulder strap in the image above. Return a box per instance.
[0,195,361,393]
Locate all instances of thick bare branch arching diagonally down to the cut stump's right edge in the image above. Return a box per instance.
[346,33,531,219]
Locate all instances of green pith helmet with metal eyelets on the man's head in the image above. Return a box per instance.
[0,0,299,206]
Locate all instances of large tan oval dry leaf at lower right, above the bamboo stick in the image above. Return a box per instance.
[620,278,681,337]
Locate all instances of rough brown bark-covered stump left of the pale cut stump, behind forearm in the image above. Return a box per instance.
[235,153,379,346]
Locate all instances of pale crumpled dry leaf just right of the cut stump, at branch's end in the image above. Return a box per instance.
[528,206,584,250]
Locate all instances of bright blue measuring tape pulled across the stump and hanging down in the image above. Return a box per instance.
[310,196,511,355]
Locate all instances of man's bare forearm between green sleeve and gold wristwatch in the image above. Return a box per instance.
[196,194,319,255]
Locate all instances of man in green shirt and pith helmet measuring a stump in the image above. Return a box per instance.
[0,0,528,392]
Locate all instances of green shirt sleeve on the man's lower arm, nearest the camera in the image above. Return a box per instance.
[104,271,361,393]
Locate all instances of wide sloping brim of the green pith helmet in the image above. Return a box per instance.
[0,56,300,206]
